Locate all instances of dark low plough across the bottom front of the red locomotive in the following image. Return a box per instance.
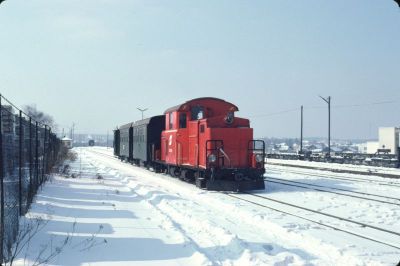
[206,180,265,191]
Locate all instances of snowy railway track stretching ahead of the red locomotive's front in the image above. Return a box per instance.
[225,193,400,250]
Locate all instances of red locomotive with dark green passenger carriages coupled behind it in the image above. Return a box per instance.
[114,97,266,191]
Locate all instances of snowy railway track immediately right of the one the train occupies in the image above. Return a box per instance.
[264,176,400,206]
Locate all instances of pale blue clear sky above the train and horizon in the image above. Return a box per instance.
[0,0,400,138]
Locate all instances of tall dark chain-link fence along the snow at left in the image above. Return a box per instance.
[0,94,60,265]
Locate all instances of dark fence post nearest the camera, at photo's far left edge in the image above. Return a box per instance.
[0,94,4,265]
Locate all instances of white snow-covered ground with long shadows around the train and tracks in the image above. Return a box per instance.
[11,148,400,266]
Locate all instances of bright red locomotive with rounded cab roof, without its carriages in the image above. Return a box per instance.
[161,98,265,191]
